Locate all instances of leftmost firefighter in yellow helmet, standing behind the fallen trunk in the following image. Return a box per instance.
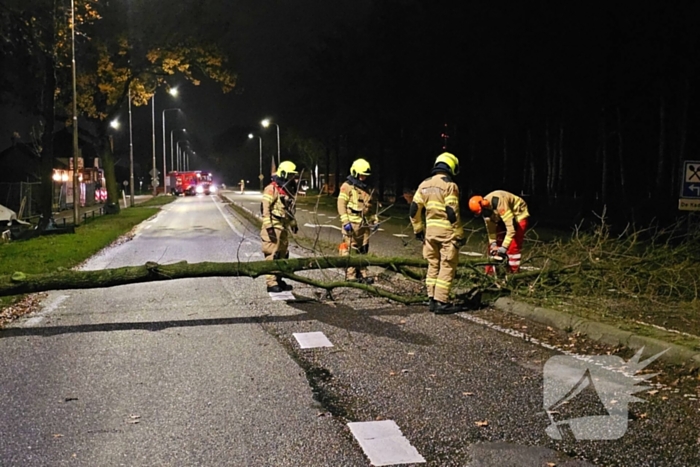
[260,161,299,292]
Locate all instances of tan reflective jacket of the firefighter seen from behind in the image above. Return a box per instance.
[410,173,464,240]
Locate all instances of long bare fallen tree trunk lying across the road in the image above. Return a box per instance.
[0,255,446,301]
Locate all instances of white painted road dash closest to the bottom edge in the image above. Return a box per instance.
[348,420,425,466]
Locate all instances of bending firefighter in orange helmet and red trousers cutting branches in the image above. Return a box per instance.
[469,190,530,274]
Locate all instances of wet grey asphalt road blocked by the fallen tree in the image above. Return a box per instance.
[0,193,700,467]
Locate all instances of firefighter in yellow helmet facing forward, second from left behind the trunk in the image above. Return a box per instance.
[338,159,376,284]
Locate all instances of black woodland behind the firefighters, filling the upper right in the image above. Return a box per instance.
[278,0,700,227]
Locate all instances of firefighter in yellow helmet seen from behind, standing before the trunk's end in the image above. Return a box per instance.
[409,152,465,314]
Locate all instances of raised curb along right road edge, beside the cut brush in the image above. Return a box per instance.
[493,297,700,368]
